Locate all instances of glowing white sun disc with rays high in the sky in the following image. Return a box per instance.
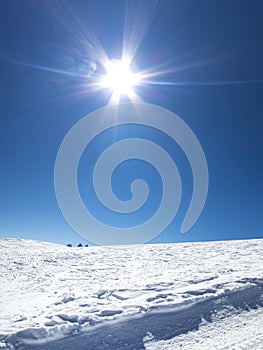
[100,58,140,102]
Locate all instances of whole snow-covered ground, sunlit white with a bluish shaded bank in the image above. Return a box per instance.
[0,239,263,350]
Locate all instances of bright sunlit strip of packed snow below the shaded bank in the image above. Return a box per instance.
[145,308,263,350]
